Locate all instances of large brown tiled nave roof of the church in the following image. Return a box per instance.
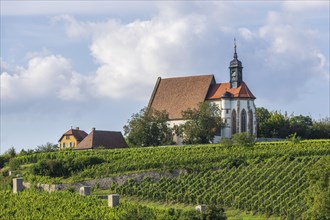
[148,75,215,120]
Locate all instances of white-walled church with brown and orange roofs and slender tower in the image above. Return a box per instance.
[148,43,257,144]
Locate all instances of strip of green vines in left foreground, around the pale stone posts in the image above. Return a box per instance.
[0,190,199,220]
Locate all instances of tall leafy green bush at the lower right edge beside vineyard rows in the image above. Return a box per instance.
[304,156,330,220]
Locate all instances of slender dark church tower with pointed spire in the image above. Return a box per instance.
[229,39,243,88]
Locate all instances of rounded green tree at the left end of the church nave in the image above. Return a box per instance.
[124,108,172,147]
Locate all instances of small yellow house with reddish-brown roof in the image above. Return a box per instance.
[58,127,87,149]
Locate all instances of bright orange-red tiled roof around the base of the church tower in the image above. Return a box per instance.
[206,82,256,100]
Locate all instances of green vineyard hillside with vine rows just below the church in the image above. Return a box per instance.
[2,140,330,219]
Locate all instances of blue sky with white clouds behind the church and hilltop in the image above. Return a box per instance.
[0,0,330,154]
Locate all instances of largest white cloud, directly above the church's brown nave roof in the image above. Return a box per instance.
[56,12,205,99]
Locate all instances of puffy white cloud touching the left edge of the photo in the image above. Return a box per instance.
[0,55,86,101]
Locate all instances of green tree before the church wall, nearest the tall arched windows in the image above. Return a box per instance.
[179,102,222,144]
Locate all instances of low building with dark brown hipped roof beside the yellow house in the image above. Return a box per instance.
[74,128,128,150]
